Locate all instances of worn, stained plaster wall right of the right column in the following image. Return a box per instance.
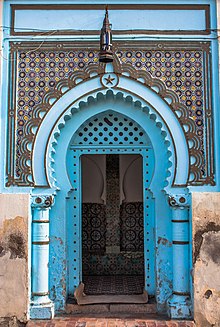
[192,193,220,327]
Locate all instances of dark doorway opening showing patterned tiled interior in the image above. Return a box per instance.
[81,154,144,295]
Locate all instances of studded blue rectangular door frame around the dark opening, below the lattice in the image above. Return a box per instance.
[67,145,156,295]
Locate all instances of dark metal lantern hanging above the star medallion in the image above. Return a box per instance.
[99,6,113,63]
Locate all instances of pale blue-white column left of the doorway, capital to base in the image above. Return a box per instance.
[30,195,54,319]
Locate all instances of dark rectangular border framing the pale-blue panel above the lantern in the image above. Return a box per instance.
[11,4,210,36]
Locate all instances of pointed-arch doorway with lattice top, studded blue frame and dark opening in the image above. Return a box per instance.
[68,111,155,295]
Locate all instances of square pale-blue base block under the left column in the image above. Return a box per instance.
[30,300,54,319]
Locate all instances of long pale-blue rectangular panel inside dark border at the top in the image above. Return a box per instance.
[15,7,206,34]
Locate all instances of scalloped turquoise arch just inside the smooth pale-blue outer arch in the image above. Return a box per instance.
[35,90,188,193]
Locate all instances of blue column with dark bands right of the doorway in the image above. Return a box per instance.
[168,194,192,319]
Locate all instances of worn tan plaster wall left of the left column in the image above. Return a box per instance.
[0,194,29,326]
